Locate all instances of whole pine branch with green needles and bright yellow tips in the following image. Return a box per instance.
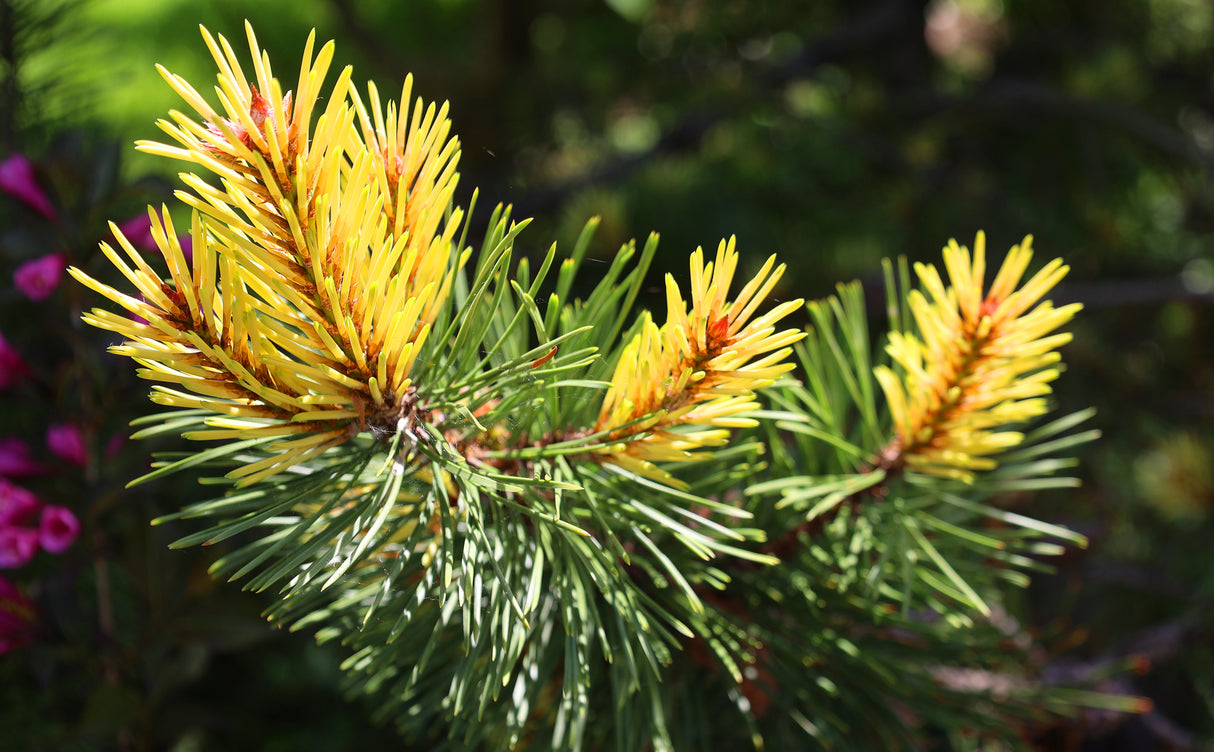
[66,23,1121,750]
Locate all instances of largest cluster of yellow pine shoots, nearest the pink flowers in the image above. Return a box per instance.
[70,24,470,484]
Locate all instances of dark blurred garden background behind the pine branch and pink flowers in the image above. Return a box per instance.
[0,0,1214,751]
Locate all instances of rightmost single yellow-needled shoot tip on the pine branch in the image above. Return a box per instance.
[875,232,1080,482]
